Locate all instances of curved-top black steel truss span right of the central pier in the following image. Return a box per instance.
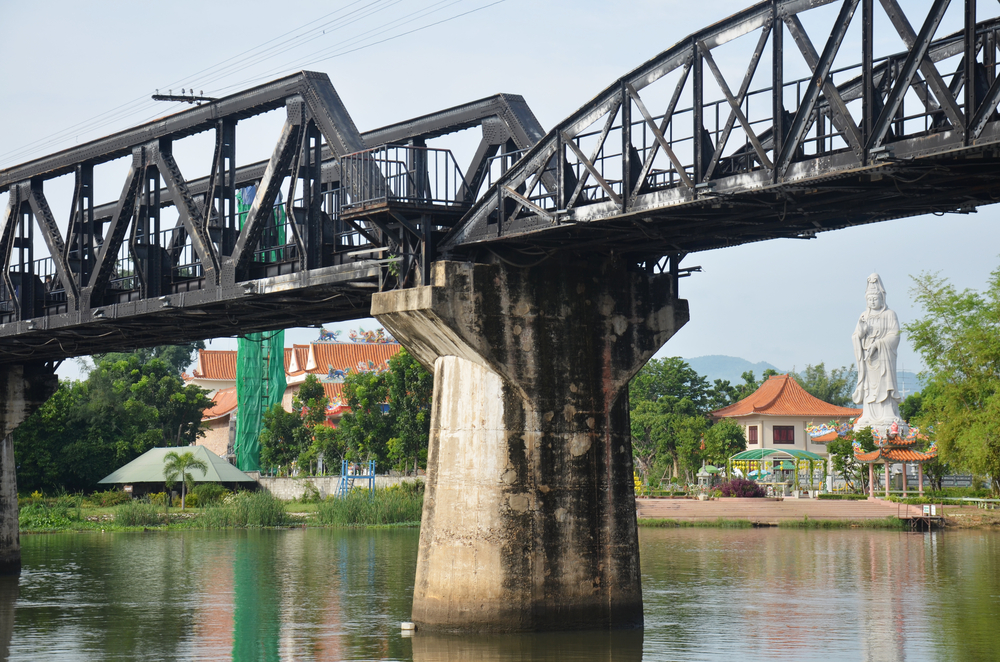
[438,0,1000,266]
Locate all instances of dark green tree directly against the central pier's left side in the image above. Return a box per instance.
[385,349,434,473]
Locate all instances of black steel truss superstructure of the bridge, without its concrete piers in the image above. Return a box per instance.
[0,0,1000,363]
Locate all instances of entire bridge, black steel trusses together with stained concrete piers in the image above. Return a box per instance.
[0,0,1000,629]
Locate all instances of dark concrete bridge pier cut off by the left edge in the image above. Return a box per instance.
[0,363,59,575]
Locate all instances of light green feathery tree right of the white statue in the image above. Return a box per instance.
[904,269,1000,493]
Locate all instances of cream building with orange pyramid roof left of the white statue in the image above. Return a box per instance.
[712,375,861,457]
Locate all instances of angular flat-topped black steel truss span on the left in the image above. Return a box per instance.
[0,72,543,362]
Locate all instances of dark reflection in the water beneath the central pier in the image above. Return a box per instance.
[412,630,642,662]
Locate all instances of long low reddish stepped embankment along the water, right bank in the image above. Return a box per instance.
[636,498,921,525]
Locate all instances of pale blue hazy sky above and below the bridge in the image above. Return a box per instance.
[0,0,1000,378]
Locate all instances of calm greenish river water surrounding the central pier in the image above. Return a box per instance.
[0,529,1000,662]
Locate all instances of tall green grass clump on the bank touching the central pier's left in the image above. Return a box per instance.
[317,488,424,526]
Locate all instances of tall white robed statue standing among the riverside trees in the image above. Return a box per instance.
[851,274,907,439]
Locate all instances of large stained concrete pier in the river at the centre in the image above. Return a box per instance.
[372,259,688,631]
